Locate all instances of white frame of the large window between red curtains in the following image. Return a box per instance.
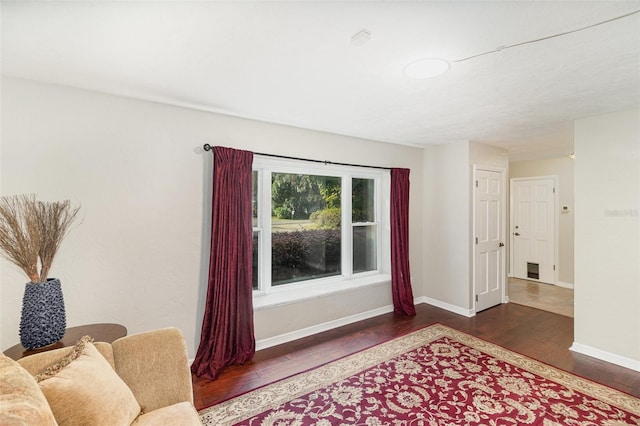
[253,155,391,309]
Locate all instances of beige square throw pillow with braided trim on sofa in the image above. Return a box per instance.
[35,336,141,426]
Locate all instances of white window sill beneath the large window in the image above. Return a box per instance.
[253,274,391,310]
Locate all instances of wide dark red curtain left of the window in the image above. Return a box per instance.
[191,147,255,380]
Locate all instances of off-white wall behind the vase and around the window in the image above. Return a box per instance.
[0,78,423,356]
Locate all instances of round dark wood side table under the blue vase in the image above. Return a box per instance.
[4,324,127,360]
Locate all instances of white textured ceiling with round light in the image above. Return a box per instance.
[1,0,640,160]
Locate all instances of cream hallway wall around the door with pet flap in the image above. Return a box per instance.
[509,155,575,287]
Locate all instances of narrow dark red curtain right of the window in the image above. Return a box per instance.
[391,169,416,315]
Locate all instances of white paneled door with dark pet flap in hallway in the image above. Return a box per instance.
[511,177,555,284]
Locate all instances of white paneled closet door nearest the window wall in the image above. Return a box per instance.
[473,167,506,312]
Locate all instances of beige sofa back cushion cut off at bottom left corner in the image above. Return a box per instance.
[0,353,57,426]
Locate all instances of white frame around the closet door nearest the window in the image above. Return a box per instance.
[471,164,508,315]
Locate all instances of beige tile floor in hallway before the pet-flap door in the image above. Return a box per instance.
[507,278,573,317]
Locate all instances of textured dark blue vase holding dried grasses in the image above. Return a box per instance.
[20,278,67,349]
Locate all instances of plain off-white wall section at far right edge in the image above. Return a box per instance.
[572,110,640,370]
